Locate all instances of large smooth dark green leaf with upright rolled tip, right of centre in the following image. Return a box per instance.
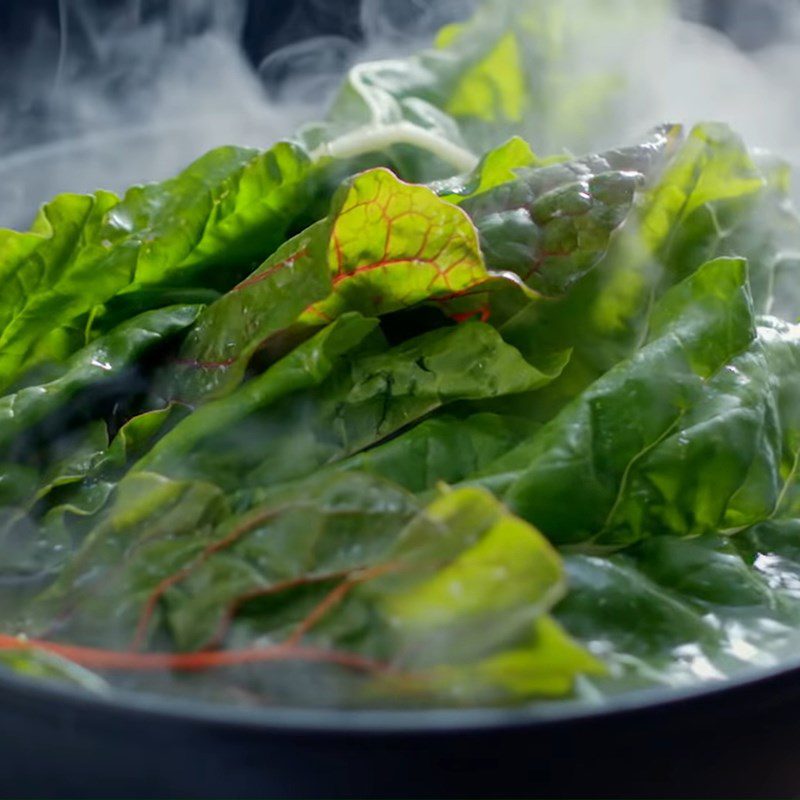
[487,259,754,545]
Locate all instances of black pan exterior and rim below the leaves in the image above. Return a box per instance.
[0,662,800,800]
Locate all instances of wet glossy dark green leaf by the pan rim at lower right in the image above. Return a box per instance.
[556,532,800,695]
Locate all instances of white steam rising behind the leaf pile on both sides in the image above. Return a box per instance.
[0,0,800,227]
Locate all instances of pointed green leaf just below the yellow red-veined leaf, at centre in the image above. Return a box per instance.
[147,316,552,489]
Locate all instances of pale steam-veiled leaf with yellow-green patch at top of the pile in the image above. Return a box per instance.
[310,0,665,162]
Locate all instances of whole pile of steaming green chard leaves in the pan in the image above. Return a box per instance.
[0,0,800,706]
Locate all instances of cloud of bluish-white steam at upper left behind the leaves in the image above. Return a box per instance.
[0,0,303,227]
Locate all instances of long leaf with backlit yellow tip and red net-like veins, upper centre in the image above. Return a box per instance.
[172,169,489,402]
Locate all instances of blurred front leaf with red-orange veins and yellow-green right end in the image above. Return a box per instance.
[23,473,603,705]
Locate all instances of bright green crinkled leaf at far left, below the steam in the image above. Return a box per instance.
[0,143,354,388]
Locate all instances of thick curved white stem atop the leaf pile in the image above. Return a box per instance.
[311,122,478,172]
